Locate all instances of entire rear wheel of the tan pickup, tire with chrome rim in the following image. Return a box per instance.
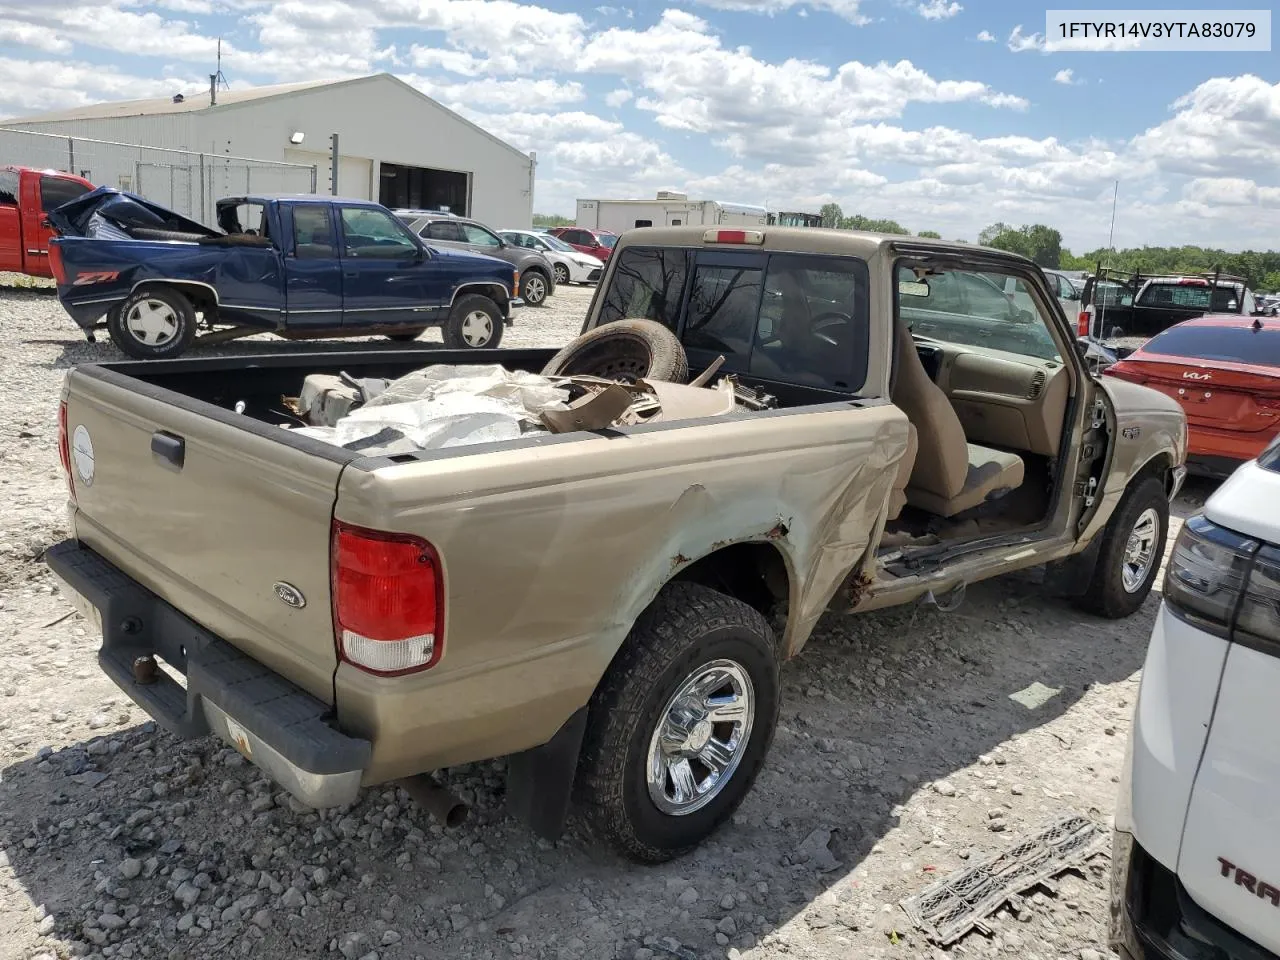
[579,582,780,863]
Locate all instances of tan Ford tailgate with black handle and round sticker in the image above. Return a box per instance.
[65,370,349,704]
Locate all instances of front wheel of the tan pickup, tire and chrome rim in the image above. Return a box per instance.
[1075,476,1169,620]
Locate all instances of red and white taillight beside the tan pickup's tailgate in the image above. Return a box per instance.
[333,521,444,677]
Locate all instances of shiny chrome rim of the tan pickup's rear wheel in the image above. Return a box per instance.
[645,660,755,817]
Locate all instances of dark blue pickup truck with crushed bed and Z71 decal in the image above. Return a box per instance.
[49,187,521,360]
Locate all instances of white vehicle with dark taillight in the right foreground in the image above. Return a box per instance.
[1111,439,1280,960]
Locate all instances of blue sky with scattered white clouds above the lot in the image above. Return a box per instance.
[0,0,1280,251]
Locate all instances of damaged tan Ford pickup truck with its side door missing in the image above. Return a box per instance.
[47,227,1187,861]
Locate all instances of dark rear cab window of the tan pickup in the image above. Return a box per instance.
[598,246,869,393]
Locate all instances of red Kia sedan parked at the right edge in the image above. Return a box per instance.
[1106,314,1280,477]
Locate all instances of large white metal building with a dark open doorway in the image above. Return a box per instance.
[0,73,535,227]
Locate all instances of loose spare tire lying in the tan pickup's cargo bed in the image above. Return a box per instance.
[543,320,689,383]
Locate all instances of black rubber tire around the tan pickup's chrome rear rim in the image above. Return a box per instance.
[576,582,781,863]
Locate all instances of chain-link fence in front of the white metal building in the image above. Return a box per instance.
[0,127,319,224]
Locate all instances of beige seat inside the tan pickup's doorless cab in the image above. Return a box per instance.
[891,324,1023,517]
